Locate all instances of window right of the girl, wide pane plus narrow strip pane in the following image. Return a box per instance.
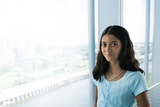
[123,0,153,86]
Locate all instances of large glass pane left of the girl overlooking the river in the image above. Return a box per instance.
[0,0,89,107]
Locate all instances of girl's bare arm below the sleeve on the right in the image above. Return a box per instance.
[136,91,151,107]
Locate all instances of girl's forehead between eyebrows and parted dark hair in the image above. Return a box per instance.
[101,34,120,42]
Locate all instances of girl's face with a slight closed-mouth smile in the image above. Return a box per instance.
[101,34,122,63]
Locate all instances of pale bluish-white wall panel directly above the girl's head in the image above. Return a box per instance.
[98,0,121,37]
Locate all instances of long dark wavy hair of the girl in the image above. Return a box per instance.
[93,25,144,81]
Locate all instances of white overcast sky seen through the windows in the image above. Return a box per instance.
[0,0,153,45]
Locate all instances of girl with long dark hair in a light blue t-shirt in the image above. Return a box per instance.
[92,25,150,107]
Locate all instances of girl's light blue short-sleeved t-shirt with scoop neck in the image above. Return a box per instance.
[92,71,148,107]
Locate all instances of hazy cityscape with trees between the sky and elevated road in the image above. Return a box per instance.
[0,36,152,89]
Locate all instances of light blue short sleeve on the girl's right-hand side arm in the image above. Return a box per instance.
[131,72,148,96]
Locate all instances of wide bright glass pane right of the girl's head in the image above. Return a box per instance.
[123,0,146,69]
